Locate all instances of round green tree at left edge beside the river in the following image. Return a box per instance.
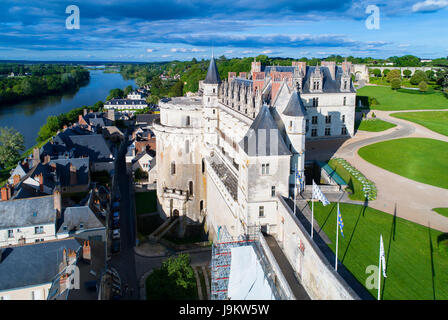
[0,127,25,167]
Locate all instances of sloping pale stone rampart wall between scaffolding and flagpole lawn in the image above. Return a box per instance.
[276,197,360,300]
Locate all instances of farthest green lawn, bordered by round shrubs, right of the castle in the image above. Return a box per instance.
[357,86,448,110]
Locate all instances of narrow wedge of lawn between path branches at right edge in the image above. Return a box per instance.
[391,111,448,136]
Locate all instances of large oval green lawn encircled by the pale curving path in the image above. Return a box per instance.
[358,138,448,188]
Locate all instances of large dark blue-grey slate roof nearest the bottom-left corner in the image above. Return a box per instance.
[0,239,82,290]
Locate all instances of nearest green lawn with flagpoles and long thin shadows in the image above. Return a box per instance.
[314,203,448,300]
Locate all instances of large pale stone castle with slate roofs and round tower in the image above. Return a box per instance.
[154,57,356,238]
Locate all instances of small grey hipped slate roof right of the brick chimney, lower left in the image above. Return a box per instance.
[57,206,104,233]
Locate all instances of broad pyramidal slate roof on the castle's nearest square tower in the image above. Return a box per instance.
[239,105,291,157]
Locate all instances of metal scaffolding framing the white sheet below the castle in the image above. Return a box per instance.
[210,226,285,300]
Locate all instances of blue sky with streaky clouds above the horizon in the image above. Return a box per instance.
[0,0,448,61]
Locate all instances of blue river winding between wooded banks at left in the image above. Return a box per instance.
[0,70,136,149]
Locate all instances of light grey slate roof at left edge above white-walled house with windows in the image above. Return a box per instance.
[0,195,56,229]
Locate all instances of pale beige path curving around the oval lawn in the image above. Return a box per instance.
[334,109,448,232]
